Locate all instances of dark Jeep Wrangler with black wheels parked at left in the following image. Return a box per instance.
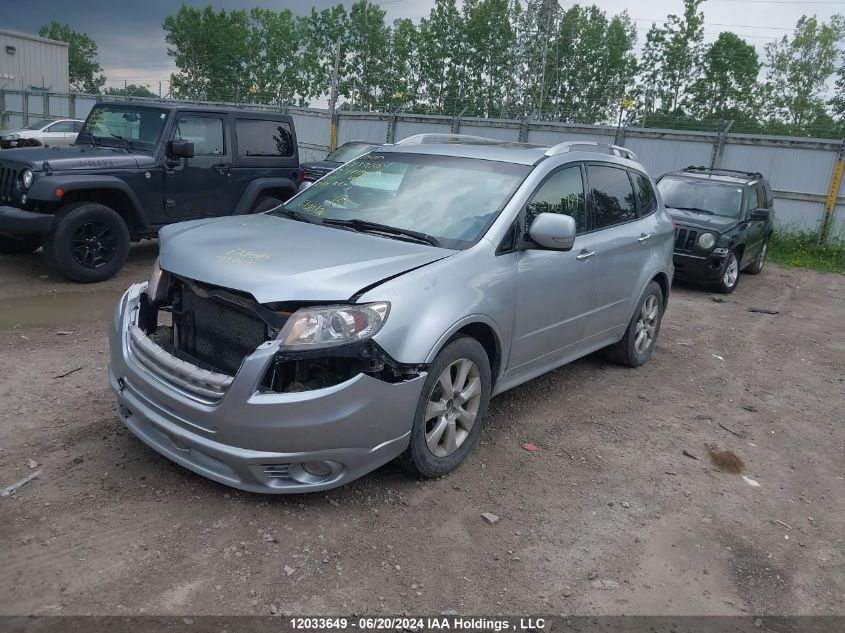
[0,102,302,282]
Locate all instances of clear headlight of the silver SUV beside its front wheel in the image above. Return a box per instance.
[278,302,390,349]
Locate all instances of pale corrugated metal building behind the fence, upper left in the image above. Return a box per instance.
[0,30,68,92]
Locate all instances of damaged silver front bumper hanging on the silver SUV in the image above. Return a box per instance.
[109,284,425,493]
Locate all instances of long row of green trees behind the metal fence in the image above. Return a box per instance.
[39,0,845,138]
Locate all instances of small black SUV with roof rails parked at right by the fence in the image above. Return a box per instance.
[657,167,775,293]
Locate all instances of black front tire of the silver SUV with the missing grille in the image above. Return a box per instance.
[399,336,491,477]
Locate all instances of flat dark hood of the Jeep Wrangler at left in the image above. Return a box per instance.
[0,145,155,171]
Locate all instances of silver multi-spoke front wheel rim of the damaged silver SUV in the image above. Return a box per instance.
[425,358,481,457]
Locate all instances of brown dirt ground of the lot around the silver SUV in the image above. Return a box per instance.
[0,243,845,615]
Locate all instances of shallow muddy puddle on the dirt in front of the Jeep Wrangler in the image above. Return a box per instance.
[0,290,123,330]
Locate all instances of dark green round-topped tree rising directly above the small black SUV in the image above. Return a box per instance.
[692,32,760,120]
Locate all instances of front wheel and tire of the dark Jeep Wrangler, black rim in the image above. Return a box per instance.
[44,202,129,283]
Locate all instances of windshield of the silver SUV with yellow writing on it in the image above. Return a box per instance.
[279,152,531,249]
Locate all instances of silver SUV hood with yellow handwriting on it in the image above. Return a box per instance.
[155,214,455,303]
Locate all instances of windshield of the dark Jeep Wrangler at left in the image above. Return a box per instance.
[76,103,167,150]
